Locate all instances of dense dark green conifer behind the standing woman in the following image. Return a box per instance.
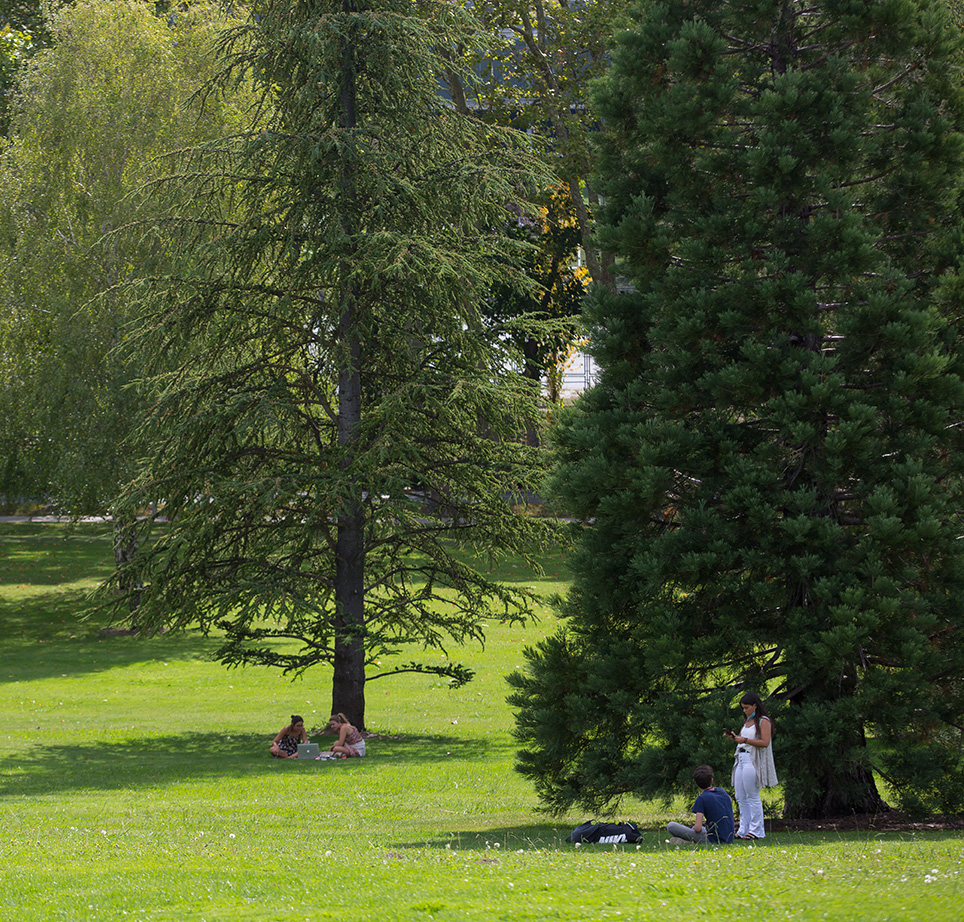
[512,0,964,817]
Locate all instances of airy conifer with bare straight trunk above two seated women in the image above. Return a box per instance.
[109,0,548,727]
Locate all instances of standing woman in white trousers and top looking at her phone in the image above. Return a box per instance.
[724,692,777,839]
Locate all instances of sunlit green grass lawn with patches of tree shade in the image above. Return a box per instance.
[0,525,964,922]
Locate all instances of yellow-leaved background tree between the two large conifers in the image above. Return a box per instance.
[445,0,625,400]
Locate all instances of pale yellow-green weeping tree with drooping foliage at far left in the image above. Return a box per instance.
[0,0,249,513]
